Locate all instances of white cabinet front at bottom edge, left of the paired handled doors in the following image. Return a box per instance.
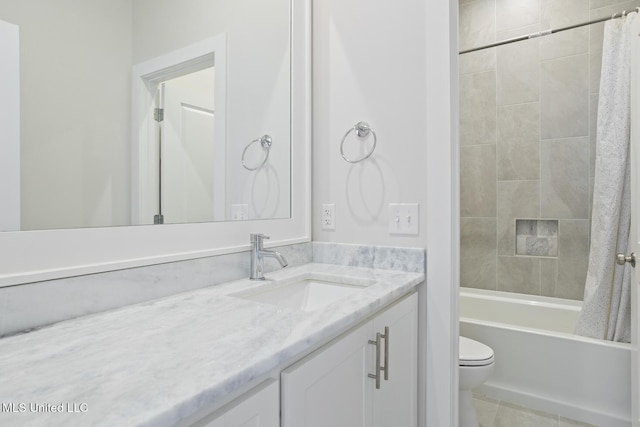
[193,380,280,427]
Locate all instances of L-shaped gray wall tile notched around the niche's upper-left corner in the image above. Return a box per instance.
[497,181,540,256]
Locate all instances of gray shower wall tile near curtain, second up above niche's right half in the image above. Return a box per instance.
[540,54,589,139]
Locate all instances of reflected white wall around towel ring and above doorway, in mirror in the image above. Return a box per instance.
[133,0,291,219]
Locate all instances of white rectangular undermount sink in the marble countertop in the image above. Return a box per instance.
[231,277,375,311]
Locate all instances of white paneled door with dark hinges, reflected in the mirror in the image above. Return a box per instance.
[154,67,220,223]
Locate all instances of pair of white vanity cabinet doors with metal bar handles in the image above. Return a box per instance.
[281,293,418,427]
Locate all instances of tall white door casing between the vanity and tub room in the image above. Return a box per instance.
[424,0,461,427]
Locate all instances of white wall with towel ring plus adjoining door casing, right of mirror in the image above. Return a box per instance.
[312,0,458,427]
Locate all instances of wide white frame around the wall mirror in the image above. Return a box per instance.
[0,0,311,287]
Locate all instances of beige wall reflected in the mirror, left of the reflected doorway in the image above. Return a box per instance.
[0,0,131,230]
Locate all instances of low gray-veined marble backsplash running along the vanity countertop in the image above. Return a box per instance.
[0,242,426,337]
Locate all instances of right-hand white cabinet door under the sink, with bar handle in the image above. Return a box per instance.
[373,294,418,427]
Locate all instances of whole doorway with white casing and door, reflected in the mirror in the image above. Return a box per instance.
[132,34,227,224]
